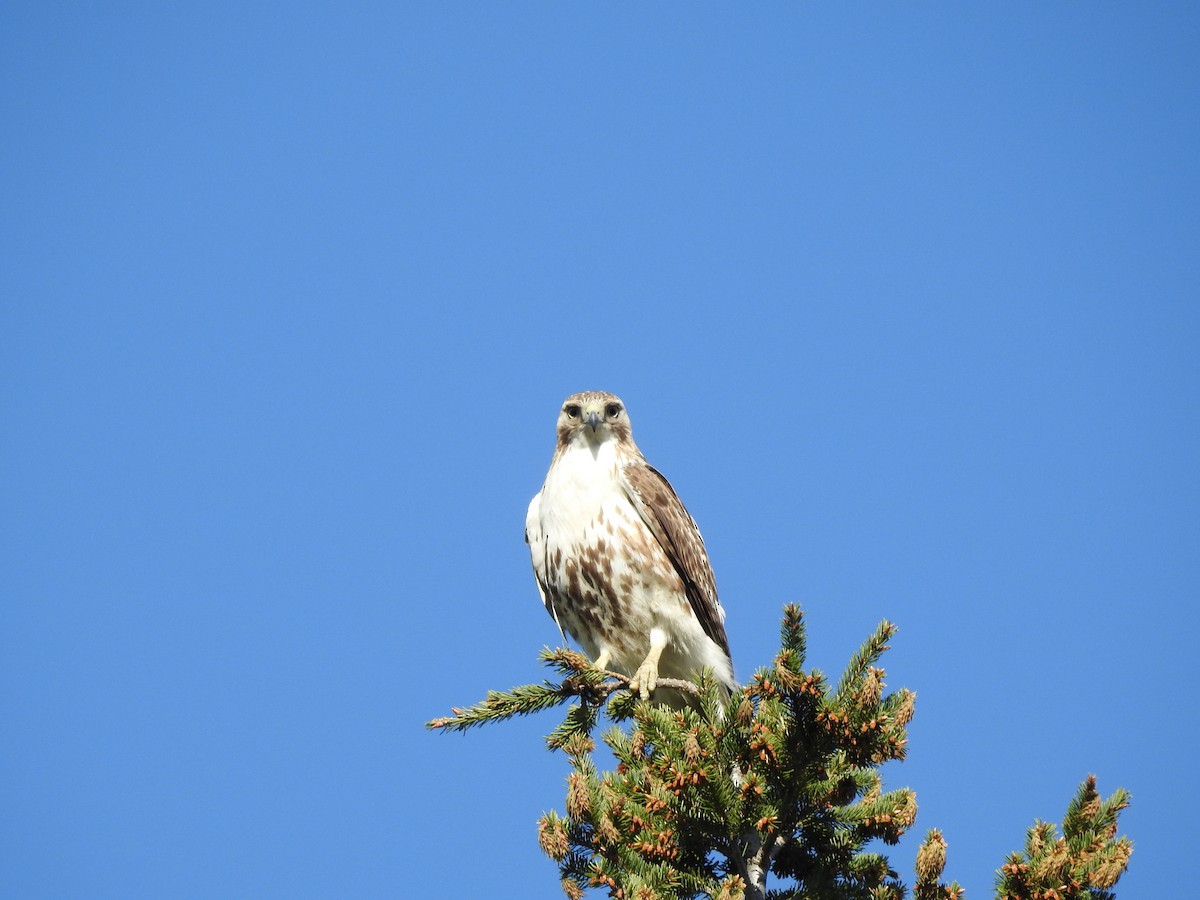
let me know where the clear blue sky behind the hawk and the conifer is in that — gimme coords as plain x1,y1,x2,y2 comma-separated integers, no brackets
0,2,1200,898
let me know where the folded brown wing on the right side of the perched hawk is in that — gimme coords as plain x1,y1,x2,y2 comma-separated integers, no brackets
622,461,730,656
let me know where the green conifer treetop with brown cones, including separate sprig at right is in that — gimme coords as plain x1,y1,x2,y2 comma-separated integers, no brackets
428,605,1133,900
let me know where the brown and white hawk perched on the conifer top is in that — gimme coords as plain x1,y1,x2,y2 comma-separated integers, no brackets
526,391,736,706
